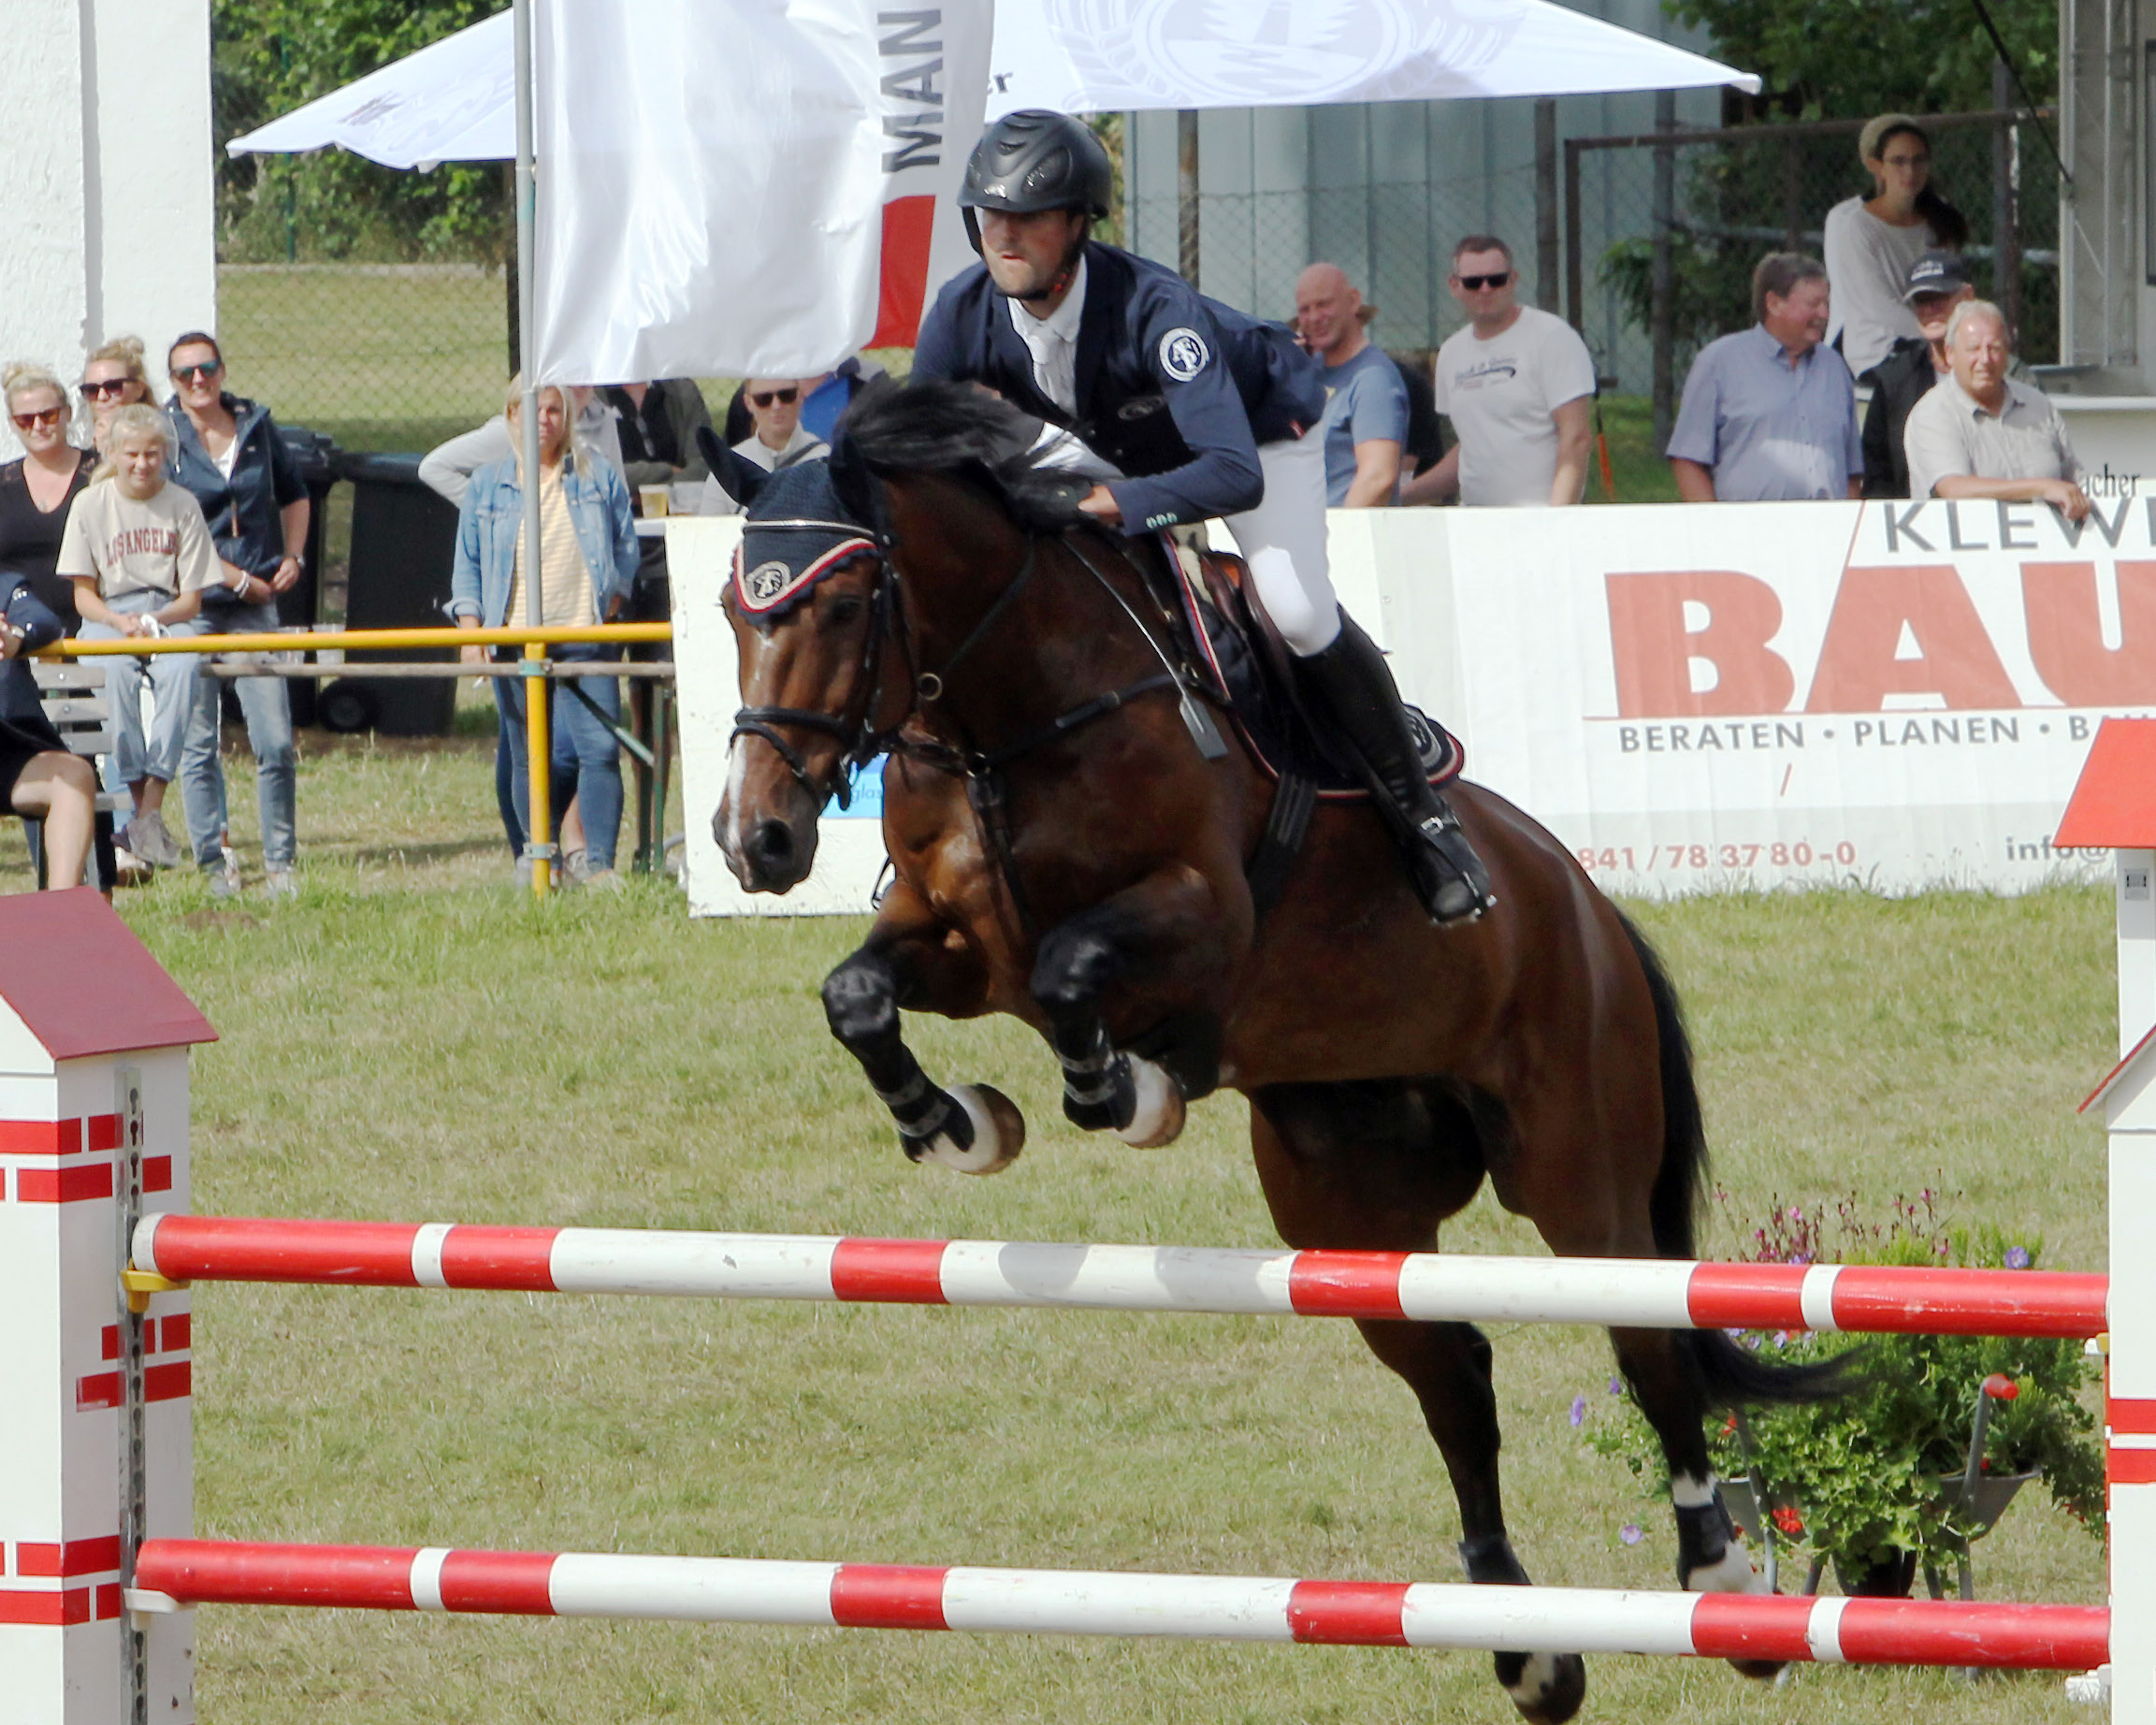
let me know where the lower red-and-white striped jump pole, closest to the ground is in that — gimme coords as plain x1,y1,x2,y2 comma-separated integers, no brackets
136,1540,2111,1671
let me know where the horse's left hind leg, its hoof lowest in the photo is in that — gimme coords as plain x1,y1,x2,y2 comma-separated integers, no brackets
1251,1082,1586,1725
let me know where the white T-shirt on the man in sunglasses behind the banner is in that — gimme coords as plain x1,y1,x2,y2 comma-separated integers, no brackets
1436,306,1596,507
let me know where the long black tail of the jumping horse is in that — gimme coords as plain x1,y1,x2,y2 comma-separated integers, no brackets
1617,912,1857,1408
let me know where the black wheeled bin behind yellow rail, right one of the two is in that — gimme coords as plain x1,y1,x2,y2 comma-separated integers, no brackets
329,455,457,737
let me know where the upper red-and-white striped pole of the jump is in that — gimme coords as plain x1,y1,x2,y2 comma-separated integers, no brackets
134,1216,2108,1337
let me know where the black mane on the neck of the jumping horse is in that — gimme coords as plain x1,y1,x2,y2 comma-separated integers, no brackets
832,380,1091,529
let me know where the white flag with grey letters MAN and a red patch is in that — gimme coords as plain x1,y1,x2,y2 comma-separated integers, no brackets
535,0,990,384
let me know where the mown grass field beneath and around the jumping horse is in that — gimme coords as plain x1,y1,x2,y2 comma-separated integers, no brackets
17,716,2113,1725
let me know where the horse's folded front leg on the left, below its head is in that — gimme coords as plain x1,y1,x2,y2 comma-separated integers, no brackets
824,882,1026,1173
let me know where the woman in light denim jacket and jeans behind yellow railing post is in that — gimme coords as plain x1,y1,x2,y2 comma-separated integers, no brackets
448,377,638,886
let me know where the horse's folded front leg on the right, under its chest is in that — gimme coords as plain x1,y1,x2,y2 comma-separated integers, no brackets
1031,864,1229,1150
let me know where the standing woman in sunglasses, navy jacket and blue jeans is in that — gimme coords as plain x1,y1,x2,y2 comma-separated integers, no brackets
164,330,311,899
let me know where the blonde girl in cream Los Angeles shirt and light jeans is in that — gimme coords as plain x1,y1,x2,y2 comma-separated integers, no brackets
61,403,218,869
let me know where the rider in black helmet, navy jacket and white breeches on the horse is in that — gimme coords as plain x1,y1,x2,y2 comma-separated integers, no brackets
914,110,1492,923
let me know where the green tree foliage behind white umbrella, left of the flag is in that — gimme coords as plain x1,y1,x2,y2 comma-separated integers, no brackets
211,0,509,263
